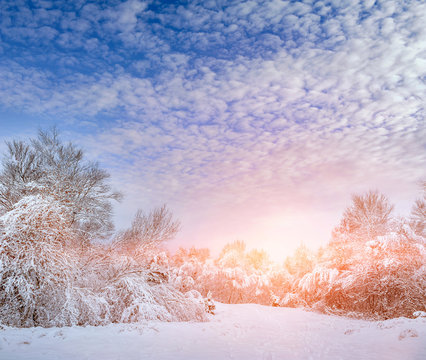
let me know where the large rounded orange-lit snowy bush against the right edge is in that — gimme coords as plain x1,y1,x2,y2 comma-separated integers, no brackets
332,233,426,318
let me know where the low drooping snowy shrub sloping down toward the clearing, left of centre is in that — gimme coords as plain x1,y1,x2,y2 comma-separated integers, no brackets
84,253,205,322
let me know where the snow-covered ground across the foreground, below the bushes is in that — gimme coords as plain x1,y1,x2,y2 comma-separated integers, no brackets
0,304,426,360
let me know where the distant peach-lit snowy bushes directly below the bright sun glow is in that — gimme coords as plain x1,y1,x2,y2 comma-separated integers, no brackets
170,241,285,305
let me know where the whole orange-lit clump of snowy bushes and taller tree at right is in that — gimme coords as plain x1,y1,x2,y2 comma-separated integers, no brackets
279,192,426,319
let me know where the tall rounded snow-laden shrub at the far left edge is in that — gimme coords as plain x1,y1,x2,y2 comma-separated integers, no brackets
0,195,78,326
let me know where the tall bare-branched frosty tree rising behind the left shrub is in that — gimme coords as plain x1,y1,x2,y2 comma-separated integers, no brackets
0,129,121,241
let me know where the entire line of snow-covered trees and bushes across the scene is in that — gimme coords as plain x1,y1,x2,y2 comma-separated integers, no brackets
0,129,426,327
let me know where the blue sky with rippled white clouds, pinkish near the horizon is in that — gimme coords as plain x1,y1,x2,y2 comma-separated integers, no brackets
0,0,426,259
